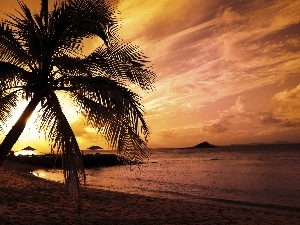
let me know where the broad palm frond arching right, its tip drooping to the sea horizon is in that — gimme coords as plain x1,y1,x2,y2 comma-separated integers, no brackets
69,77,149,161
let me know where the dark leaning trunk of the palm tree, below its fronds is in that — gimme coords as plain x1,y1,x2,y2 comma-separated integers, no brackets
0,95,41,166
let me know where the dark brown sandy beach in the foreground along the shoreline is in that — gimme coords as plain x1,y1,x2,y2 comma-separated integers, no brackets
0,162,300,225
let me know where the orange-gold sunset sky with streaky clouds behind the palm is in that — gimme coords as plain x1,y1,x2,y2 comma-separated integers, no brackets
0,0,300,153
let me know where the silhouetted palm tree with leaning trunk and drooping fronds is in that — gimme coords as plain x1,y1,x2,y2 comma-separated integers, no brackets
0,0,155,213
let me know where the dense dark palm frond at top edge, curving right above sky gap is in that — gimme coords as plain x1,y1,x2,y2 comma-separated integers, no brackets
49,0,116,55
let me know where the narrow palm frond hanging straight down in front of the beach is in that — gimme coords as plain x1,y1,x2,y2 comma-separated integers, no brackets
39,92,85,214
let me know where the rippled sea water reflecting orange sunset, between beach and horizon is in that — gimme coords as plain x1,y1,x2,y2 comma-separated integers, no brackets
34,144,300,210
